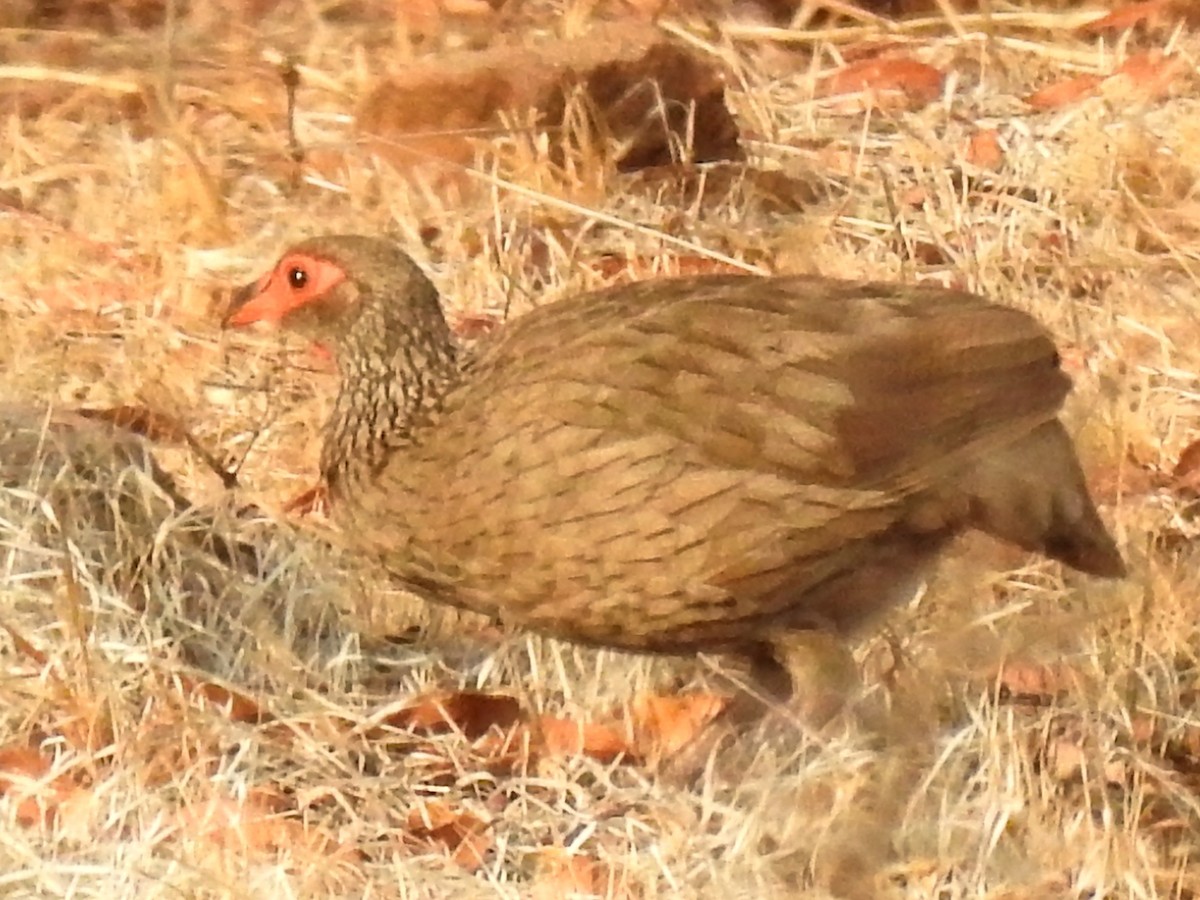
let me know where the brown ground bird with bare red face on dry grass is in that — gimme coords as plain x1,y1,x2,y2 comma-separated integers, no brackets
223,235,1127,698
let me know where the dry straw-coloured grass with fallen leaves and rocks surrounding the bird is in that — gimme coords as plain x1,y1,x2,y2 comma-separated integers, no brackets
0,0,1200,900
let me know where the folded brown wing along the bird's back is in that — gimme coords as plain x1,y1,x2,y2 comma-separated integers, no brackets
458,276,1070,501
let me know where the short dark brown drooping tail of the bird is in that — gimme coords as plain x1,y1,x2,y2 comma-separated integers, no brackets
960,420,1126,578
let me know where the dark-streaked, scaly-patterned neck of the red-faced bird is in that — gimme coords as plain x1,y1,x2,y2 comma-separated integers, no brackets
320,295,461,492
